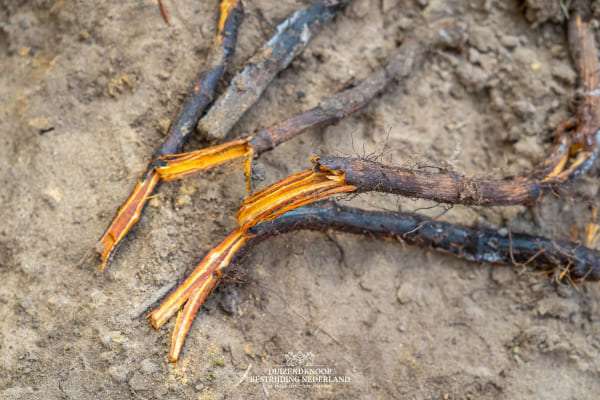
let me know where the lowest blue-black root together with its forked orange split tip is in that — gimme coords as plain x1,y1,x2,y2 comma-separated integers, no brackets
156,192,600,362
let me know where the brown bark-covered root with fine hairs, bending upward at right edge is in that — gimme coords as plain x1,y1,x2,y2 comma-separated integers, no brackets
317,7,600,206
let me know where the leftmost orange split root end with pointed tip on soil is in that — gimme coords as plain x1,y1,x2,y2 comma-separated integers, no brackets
98,171,160,270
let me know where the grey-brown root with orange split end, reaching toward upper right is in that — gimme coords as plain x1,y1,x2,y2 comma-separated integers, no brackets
157,19,465,181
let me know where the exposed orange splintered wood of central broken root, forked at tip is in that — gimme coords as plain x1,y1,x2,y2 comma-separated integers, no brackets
148,162,356,362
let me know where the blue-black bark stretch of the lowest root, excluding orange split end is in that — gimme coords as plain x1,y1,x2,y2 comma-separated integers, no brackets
247,202,600,281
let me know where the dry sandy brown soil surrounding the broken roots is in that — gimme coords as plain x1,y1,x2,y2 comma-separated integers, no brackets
0,0,600,400
